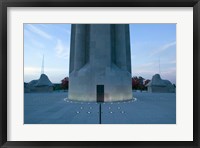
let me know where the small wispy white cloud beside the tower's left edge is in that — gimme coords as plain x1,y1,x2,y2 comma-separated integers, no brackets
55,39,69,59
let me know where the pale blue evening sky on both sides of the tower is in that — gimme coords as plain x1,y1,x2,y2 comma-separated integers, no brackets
24,24,176,84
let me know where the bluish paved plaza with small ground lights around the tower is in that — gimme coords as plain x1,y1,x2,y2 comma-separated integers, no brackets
24,92,176,124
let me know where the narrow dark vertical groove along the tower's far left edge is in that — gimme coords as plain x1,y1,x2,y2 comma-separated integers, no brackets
69,24,76,73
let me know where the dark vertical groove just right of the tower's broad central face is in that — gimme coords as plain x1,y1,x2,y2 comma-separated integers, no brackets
110,24,116,64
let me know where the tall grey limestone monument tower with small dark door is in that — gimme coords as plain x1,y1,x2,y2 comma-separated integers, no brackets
68,24,132,102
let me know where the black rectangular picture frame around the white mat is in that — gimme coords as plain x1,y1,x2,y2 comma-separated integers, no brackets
0,0,200,148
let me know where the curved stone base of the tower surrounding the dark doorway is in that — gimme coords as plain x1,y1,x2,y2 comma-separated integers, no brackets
68,66,132,102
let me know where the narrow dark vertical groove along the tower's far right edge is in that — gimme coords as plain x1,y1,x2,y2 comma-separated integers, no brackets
125,24,131,73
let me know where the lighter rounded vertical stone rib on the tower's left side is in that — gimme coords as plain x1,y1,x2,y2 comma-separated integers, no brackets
74,24,86,70
